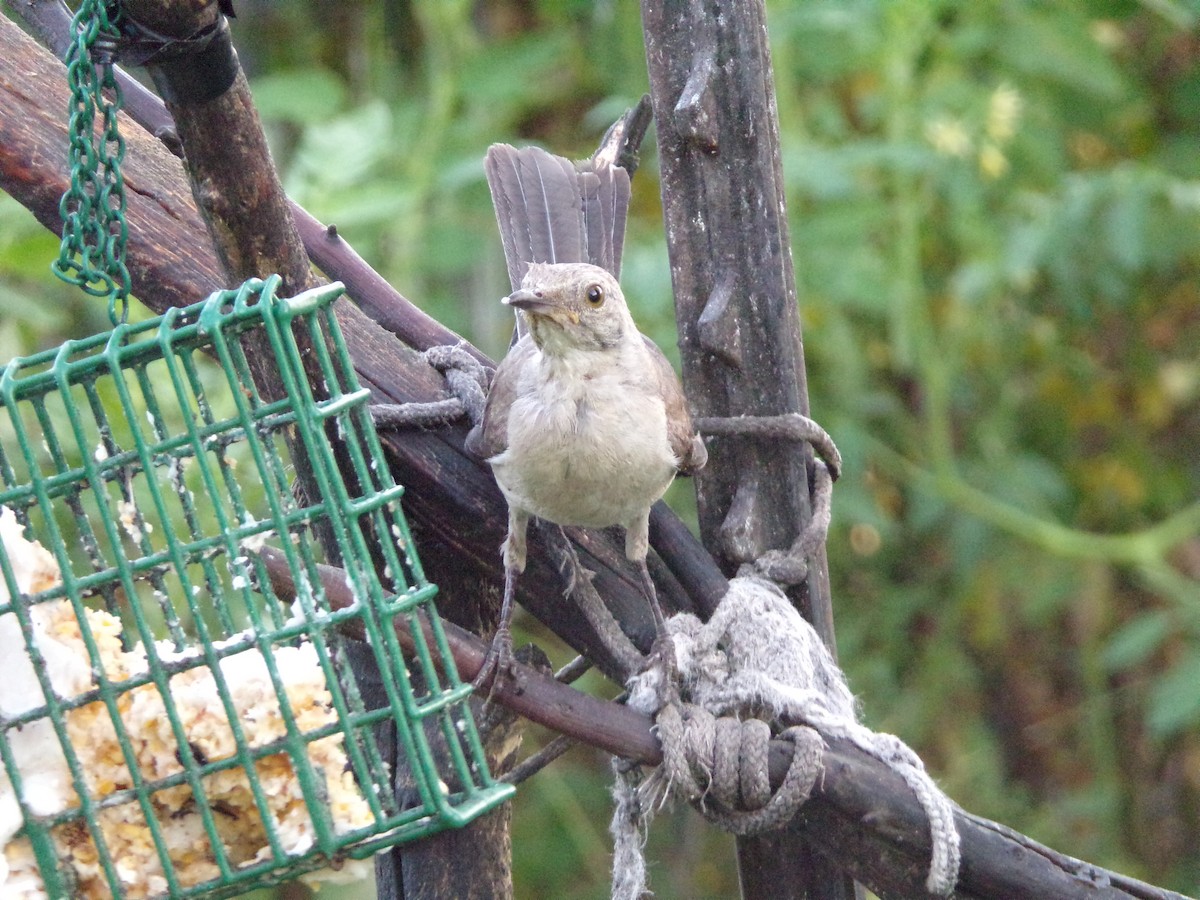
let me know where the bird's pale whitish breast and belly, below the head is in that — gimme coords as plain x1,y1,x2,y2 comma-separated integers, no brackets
490,336,677,528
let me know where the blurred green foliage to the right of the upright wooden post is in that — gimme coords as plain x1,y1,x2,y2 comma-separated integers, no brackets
772,0,1200,890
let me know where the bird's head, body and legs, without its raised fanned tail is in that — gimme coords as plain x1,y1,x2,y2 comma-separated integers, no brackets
467,263,708,685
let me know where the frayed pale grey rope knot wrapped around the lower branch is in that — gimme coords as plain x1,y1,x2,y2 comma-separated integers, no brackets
612,576,960,900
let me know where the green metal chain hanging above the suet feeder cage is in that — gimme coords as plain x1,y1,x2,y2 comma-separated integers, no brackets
50,0,130,325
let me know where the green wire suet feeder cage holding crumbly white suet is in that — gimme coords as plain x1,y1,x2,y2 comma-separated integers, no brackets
0,278,512,898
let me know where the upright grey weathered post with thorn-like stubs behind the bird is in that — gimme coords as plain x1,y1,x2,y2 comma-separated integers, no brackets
642,0,856,900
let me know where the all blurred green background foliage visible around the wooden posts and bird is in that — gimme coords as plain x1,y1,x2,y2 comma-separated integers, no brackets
0,0,1200,898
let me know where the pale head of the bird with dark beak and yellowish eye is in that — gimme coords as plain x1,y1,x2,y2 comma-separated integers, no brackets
504,263,636,353
